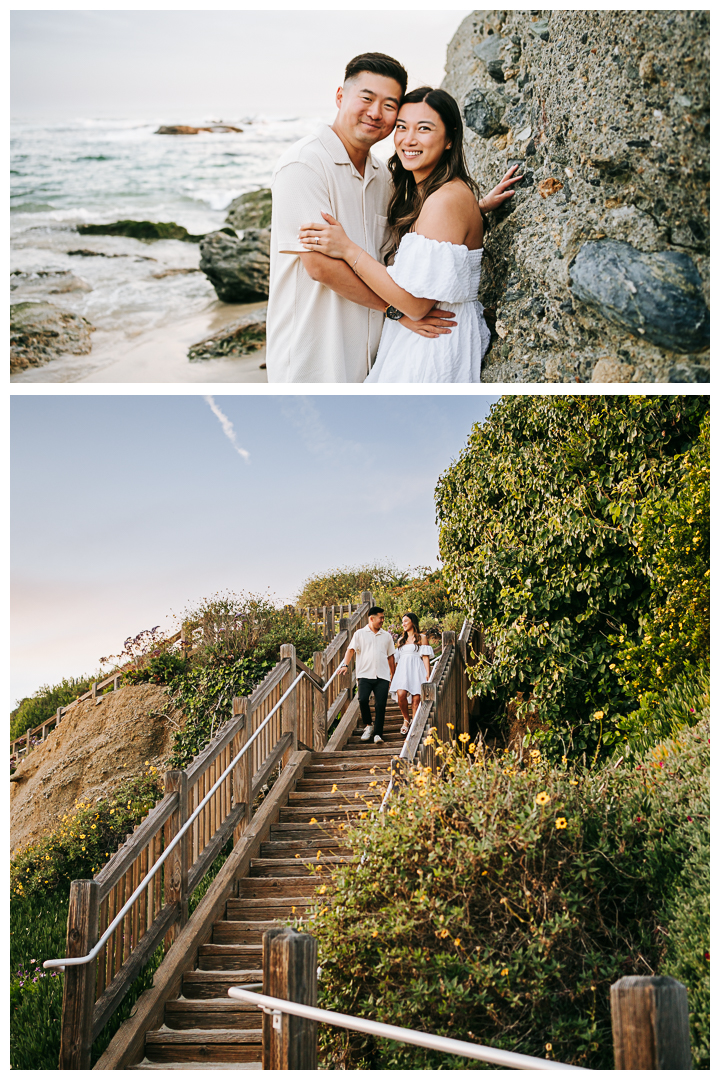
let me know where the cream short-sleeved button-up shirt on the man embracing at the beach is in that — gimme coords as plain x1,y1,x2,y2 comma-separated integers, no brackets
267,124,391,382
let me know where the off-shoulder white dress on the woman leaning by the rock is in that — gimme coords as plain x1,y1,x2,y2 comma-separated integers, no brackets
365,232,490,382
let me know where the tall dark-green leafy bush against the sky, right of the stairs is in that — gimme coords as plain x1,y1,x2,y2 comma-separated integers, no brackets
436,395,708,757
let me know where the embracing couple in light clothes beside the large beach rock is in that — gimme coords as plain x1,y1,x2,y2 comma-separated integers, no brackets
267,53,520,382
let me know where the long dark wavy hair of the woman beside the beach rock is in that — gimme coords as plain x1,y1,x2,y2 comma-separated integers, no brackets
388,86,480,257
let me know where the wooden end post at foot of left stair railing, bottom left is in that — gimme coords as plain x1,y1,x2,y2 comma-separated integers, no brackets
59,881,99,1069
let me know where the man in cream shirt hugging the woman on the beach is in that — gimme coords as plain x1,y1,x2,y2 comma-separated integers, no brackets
267,53,453,382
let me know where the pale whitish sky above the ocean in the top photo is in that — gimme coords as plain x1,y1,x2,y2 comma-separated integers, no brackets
11,10,470,123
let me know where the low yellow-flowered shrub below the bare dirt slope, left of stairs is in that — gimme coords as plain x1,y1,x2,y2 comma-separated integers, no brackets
10,766,163,897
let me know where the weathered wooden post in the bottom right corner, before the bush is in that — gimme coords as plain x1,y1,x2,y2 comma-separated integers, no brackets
610,975,692,1070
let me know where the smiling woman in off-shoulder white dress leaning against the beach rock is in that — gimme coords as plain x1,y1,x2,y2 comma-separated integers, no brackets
299,86,496,382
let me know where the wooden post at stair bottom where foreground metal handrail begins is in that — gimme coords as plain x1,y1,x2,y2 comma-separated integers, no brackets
262,930,317,1069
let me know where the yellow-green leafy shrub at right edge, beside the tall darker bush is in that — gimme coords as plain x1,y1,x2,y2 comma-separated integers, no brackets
617,415,710,700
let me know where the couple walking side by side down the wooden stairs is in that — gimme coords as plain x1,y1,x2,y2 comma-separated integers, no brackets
338,607,433,743
